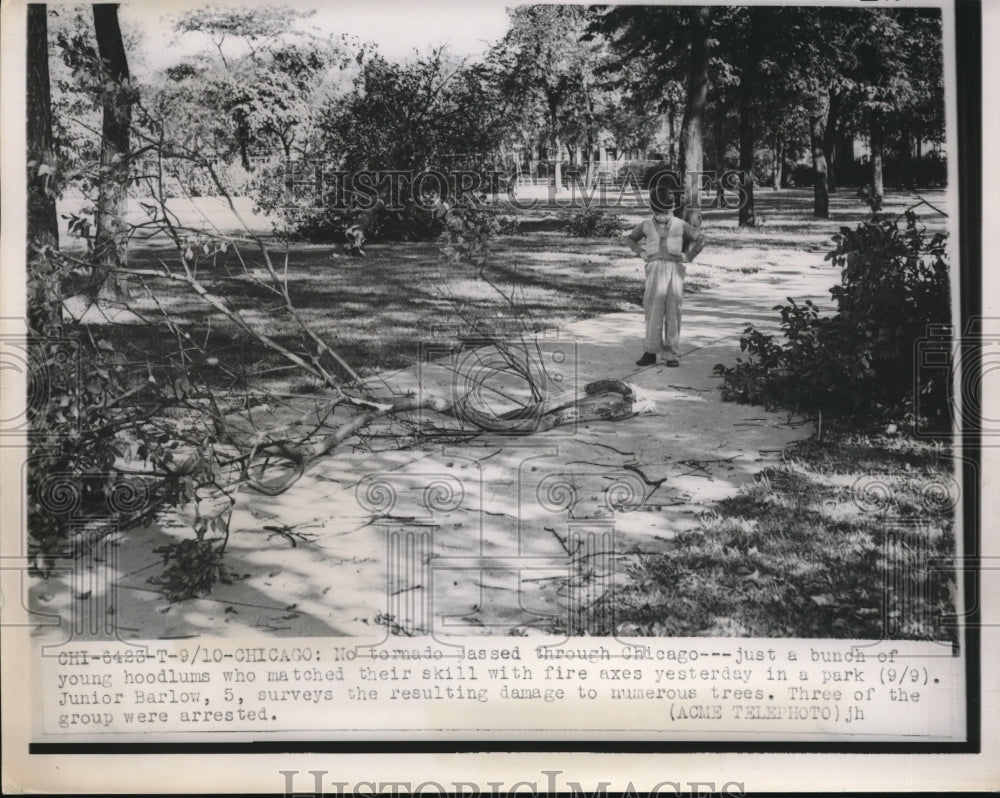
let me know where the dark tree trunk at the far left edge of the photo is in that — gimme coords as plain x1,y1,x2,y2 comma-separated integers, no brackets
27,3,59,259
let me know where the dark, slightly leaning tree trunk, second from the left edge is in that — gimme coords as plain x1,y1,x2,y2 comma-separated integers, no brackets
89,3,132,298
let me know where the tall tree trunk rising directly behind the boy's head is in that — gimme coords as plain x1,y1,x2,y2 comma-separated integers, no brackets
678,6,712,227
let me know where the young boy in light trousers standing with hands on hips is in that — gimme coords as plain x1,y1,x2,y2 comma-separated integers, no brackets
622,190,705,366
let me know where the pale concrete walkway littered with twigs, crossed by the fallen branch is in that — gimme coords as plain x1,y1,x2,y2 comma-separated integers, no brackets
32,244,836,639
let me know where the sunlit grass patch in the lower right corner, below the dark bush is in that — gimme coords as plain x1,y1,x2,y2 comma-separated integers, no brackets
611,424,956,641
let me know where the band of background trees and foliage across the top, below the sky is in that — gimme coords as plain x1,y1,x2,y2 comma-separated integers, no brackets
29,5,944,263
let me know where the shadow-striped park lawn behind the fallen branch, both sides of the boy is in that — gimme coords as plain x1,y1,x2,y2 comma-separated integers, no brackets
106,190,932,392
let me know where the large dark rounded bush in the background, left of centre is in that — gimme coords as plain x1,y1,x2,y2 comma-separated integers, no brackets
252,48,509,242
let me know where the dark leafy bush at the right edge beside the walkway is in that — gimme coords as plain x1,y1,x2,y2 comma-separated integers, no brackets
715,209,951,421
